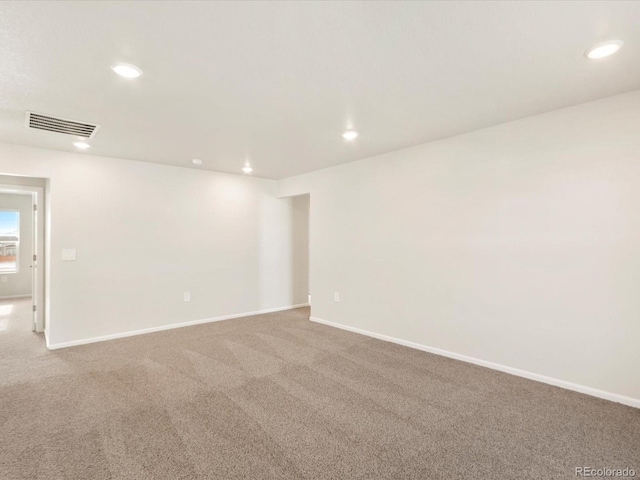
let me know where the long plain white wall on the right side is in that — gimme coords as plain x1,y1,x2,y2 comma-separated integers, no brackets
279,91,640,399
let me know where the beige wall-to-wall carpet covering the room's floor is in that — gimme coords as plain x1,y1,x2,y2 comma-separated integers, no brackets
0,302,640,480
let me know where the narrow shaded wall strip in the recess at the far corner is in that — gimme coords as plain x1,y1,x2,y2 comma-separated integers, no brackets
291,195,309,304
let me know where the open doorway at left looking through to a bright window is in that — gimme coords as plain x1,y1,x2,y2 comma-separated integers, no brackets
0,184,45,332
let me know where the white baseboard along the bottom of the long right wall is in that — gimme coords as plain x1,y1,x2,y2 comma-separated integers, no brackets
309,317,640,408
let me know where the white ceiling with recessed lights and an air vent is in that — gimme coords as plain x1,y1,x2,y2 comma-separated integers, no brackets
0,1,640,178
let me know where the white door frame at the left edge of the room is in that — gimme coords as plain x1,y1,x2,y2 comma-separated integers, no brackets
0,184,48,332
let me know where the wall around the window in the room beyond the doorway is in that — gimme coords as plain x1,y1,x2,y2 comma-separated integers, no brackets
0,193,33,298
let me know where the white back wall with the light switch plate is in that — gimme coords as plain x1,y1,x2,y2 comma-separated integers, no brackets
0,144,294,345
